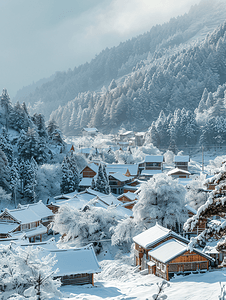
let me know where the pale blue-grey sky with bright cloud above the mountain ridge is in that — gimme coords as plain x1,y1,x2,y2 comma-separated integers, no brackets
0,0,200,98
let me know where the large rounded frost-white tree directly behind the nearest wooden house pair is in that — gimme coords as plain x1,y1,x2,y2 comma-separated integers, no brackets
133,174,187,231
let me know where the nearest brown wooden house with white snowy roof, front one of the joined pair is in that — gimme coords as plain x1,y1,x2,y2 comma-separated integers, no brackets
147,239,213,280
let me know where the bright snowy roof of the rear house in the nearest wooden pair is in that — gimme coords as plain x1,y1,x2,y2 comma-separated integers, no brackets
133,224,189,249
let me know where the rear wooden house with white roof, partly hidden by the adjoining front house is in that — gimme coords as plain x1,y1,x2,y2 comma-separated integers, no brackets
133,223,189,270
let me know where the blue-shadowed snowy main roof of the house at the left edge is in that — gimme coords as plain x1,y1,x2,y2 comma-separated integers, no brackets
0,206,41,224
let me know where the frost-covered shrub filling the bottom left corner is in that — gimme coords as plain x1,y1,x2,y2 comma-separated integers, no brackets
0,245,60,300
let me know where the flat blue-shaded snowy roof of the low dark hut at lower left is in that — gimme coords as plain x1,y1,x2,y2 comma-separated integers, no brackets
46,245,101,276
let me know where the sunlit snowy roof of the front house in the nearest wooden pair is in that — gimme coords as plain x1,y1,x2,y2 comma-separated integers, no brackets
148,239,213,263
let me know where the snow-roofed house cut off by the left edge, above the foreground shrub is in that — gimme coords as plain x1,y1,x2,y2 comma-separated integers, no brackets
0,205,47,242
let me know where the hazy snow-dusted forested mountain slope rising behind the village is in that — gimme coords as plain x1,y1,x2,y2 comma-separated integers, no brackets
15,0,226,134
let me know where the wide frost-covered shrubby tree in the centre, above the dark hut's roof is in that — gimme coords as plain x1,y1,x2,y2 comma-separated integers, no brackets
53,205,118,253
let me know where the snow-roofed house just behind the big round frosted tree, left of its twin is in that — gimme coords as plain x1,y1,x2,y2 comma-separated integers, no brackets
138,155,164,174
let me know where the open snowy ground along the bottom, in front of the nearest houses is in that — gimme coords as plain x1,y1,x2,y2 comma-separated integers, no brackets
61,260,226,300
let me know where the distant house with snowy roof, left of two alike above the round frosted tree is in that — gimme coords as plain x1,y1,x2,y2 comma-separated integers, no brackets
138,155,164,177
